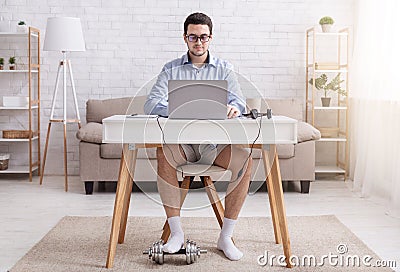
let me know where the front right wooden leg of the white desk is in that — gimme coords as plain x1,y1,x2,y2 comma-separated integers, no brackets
270,145,292,268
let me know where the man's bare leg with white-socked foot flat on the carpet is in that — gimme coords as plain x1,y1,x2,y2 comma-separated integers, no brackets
214,145,252,261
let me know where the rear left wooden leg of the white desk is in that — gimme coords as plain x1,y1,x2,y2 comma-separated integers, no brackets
118,146,138,244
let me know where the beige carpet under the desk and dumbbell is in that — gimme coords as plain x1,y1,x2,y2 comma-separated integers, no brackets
11,216,392,272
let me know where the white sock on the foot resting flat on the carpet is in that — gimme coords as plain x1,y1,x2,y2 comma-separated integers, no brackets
217,217,243,261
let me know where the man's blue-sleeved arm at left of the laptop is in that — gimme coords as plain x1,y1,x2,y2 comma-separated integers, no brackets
144,66,168,116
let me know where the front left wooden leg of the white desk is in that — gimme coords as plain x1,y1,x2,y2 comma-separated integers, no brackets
106,144,132,268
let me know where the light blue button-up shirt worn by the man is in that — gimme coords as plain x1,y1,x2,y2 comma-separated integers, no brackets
144,52,245,116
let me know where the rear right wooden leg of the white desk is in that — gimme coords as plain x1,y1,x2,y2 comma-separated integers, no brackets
262,149,282,244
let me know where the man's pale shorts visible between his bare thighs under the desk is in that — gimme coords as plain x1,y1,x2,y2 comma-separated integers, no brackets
181,144,227,165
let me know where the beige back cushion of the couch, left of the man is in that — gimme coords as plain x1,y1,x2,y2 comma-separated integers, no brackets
86,96,146,123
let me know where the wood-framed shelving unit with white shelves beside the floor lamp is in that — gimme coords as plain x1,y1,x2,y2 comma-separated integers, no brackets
0,27,40,181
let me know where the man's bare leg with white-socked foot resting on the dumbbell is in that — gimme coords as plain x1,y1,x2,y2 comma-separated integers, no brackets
157,145,186,253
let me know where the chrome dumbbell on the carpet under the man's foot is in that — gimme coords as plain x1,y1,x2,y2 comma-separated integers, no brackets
143,240,207,264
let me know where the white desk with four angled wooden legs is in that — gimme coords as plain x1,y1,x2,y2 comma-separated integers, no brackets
103,115,297,268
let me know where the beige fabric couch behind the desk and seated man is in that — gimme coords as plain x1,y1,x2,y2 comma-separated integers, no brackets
77,96,320,194
